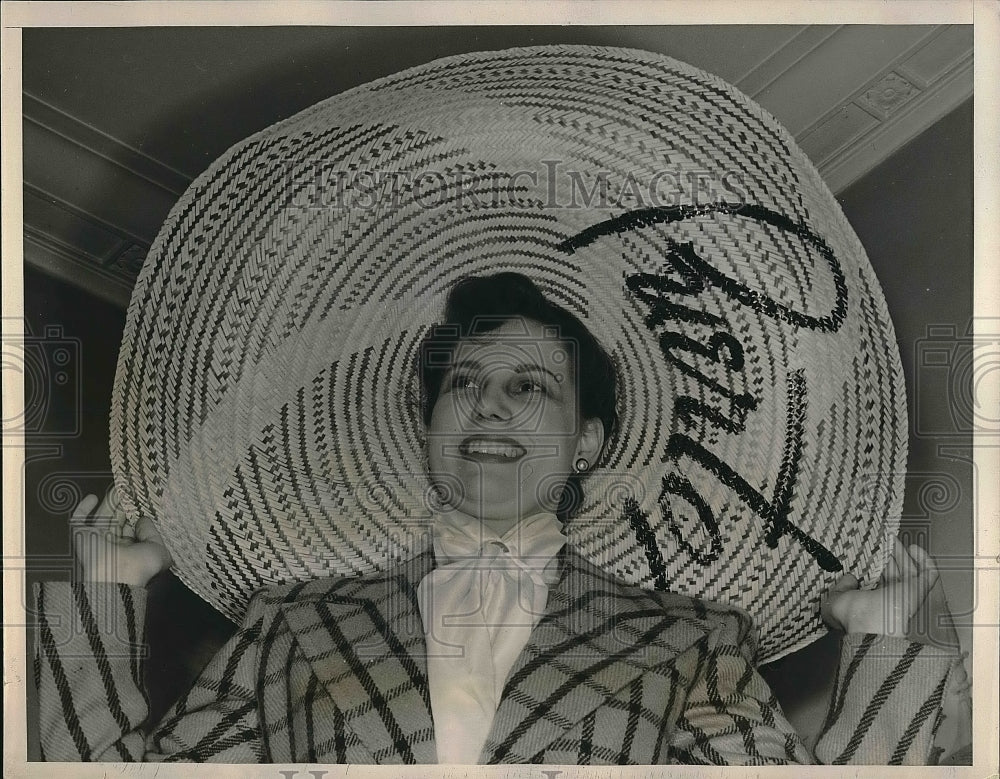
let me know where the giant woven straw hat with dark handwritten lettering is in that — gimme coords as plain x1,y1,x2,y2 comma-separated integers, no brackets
112,46,905,657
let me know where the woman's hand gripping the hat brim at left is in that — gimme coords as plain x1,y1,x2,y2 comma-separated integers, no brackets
70,491,173,587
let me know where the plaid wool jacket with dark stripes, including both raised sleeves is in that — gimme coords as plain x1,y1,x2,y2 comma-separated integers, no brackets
35,551,954,765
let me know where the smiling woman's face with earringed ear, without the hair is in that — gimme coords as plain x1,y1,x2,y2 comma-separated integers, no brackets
427,318,604,530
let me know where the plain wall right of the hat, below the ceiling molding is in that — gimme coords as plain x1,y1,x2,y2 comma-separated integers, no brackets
839,100,968,649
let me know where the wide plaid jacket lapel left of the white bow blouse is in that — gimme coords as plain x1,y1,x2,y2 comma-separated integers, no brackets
282,552,437,763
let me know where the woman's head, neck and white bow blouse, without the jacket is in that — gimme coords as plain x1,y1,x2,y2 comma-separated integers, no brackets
417,273,615,763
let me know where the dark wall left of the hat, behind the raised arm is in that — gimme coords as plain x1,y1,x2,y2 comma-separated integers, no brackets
23,268,232,759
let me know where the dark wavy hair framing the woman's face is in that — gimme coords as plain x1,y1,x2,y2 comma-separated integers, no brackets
419,272,618,519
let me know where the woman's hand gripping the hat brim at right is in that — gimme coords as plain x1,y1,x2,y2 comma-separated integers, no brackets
820,538,947,638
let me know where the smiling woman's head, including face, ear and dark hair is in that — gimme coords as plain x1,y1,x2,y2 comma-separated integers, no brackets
420,273,618,526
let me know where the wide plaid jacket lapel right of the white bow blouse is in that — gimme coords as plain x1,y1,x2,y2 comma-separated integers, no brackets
480,552,701,763
